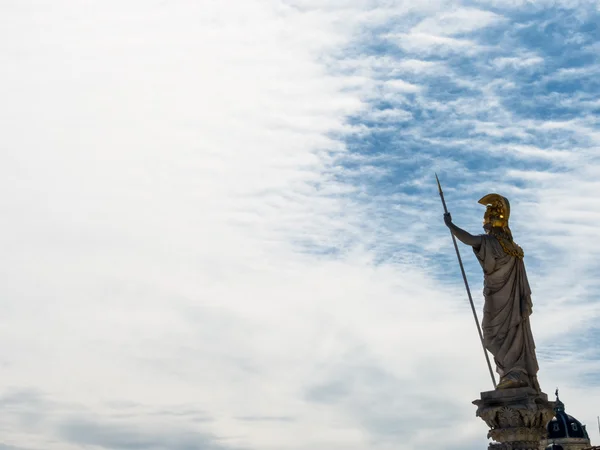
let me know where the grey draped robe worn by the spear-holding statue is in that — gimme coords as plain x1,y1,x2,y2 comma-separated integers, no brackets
473,235,540,391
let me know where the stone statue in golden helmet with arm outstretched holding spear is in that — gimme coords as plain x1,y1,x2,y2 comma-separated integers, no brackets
440,193,541,392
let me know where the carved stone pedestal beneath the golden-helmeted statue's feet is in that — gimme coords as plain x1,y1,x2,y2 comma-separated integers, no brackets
473,388,554,450
